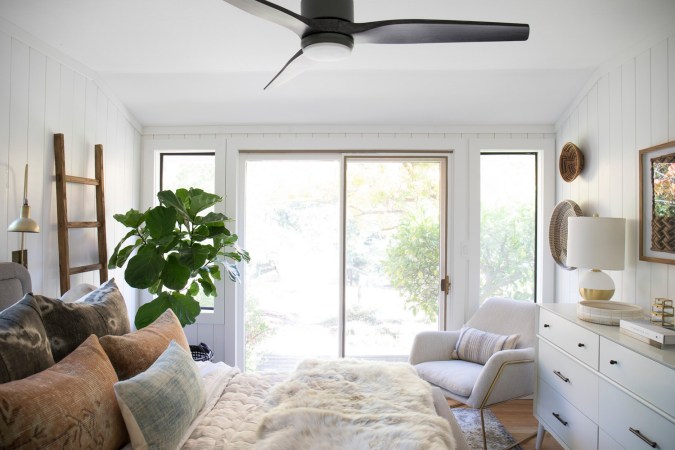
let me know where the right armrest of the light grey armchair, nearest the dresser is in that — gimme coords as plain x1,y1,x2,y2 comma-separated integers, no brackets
467,347,534,408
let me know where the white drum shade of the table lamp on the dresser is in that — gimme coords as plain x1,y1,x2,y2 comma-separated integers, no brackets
567,217,626,270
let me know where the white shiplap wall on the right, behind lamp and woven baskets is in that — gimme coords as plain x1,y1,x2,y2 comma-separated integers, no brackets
556,36,675,308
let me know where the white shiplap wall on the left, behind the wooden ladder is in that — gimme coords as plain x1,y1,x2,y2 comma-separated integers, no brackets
0,21,141,317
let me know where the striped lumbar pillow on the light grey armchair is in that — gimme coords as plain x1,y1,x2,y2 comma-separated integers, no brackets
452,327,519,364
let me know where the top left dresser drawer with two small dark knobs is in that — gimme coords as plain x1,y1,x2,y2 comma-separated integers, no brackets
539,308,600,370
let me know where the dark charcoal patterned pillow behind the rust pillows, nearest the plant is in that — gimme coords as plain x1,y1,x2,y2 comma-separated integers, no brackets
35,279,130,362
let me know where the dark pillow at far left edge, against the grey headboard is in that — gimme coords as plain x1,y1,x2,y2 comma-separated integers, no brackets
0,294,54,383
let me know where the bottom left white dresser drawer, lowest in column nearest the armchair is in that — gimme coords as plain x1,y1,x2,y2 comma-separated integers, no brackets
536,378,598,450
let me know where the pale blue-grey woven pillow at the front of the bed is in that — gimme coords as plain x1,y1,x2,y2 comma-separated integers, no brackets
114,341,206,450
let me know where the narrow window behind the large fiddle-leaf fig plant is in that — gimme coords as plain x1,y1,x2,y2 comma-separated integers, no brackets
159,151,216,310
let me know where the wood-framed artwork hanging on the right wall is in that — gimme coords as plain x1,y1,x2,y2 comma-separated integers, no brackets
639,141,675,264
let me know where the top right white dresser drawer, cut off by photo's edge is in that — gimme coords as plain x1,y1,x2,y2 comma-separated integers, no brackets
600,337,675,417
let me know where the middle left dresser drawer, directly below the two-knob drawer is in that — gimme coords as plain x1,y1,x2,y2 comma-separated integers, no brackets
537,339,598,422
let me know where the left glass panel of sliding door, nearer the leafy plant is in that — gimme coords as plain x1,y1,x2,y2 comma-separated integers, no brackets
244,160,340,371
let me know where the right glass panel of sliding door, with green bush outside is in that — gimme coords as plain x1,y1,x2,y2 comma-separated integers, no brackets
344,157,445,361
